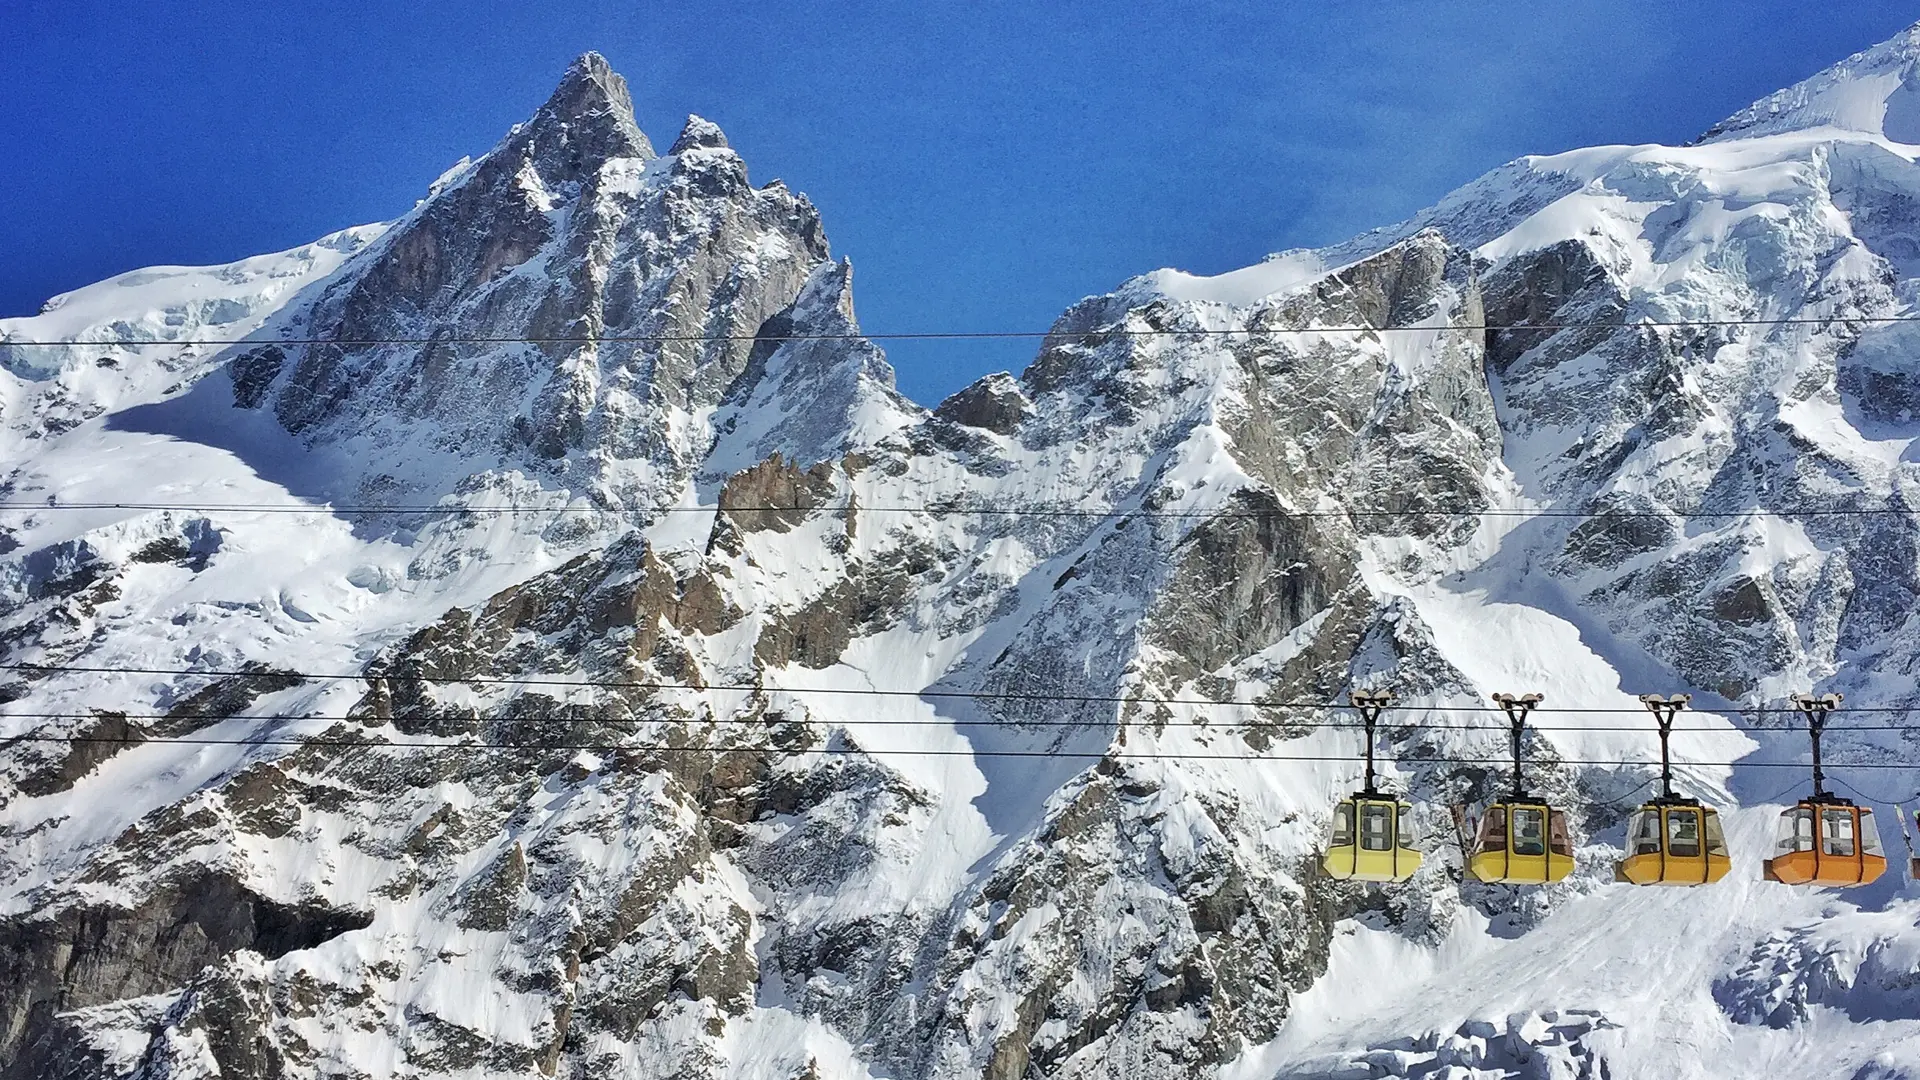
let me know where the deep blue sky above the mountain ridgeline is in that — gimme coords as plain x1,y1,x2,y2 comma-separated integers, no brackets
0,0,1920,402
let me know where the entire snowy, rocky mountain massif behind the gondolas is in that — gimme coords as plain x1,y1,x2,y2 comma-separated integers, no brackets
0,27,1920,1080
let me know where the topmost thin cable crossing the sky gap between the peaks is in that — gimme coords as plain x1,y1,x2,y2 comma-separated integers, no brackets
0,315,1920,348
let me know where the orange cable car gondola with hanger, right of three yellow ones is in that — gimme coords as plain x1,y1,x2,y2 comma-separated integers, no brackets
1764,694,1887,888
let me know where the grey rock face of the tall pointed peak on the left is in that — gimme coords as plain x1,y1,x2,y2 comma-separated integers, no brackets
232,54,848,503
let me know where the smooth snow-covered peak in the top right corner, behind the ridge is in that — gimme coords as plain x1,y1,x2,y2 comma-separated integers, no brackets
1695,23,1920,142
